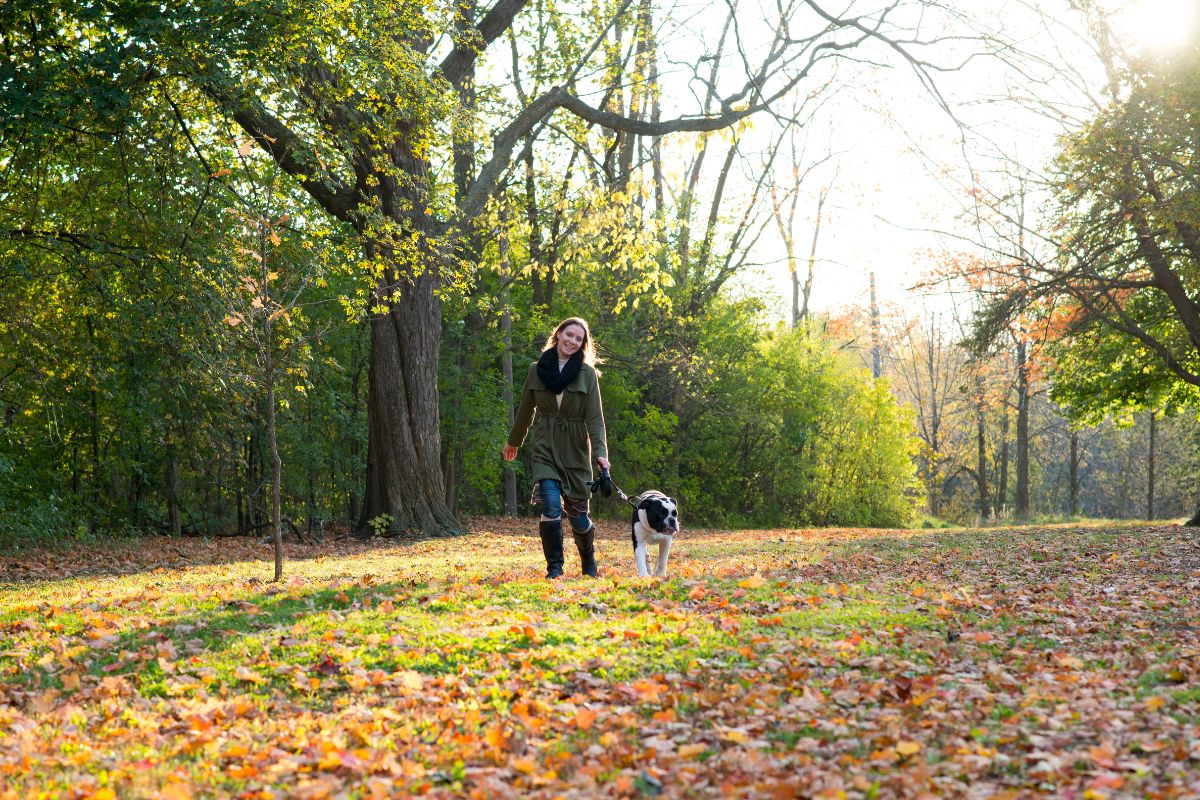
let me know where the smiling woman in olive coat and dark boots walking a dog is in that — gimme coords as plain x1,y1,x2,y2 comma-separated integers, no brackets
504,317,610,579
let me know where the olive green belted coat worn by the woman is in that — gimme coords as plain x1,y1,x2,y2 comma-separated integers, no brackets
509,361,608,500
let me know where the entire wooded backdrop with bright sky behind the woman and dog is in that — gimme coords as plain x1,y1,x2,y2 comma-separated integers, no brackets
0,0,1200,547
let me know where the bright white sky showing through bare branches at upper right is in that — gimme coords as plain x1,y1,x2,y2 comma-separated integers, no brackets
490,0,1200,319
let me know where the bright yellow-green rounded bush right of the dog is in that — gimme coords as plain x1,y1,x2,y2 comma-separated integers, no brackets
667,320,916,525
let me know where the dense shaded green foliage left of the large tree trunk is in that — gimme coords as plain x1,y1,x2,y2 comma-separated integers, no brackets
0,43,365,545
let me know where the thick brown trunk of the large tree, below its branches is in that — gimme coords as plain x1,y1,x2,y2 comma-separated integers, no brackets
358,263,460,537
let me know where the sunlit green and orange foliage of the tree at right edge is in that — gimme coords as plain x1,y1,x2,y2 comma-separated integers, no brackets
1046,47,1200,423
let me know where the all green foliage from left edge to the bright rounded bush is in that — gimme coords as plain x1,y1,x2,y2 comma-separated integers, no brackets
0,0,913,542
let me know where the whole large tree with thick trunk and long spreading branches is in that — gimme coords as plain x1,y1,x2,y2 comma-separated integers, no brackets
0,0,998,533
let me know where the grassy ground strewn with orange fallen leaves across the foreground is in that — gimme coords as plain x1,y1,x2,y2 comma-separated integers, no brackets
0,519,1200,799
